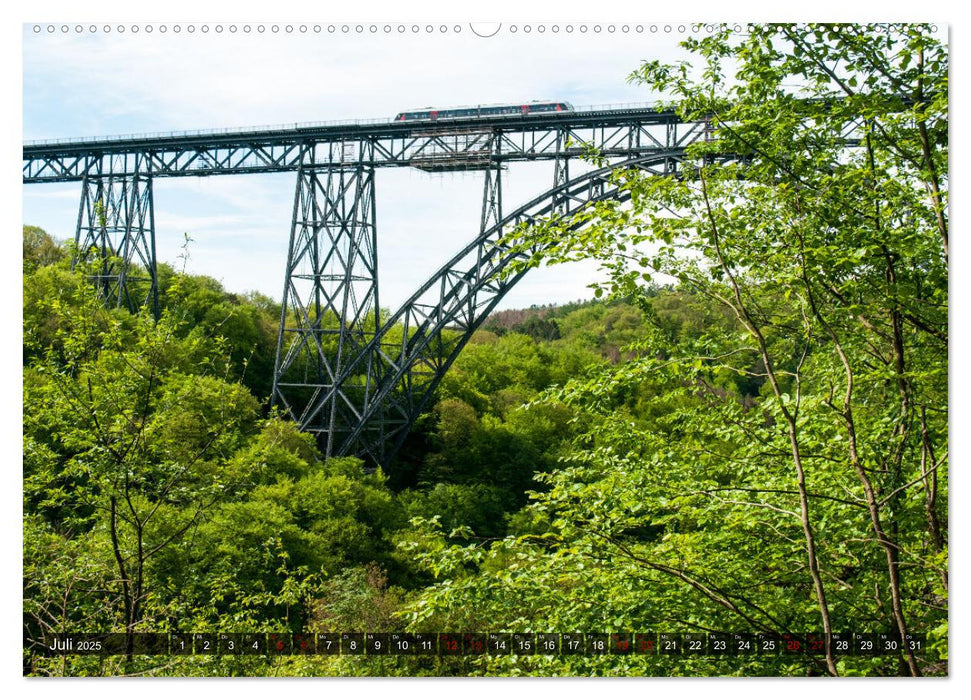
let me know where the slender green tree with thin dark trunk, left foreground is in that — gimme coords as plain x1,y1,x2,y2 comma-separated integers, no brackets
24,272,258,659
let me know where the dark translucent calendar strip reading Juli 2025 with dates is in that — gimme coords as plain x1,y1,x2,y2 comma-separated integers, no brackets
24,632,926,657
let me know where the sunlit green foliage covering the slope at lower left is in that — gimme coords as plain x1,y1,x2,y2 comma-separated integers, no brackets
24,256,406,675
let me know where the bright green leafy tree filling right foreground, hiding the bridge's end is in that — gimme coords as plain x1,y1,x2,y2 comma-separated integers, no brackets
402,25,948,675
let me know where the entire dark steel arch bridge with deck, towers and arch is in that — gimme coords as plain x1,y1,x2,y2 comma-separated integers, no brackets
23,106,710,467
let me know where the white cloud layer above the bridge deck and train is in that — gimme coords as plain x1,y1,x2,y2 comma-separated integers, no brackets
24,25,675,138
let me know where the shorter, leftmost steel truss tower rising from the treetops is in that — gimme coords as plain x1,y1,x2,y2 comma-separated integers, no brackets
73,154,158,318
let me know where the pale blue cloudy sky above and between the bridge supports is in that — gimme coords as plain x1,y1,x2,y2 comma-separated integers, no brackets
23,22,691,308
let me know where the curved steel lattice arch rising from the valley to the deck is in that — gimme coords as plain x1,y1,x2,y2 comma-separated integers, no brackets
296,149,684,466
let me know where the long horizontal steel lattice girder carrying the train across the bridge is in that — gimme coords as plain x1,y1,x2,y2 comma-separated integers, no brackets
23,109,705,183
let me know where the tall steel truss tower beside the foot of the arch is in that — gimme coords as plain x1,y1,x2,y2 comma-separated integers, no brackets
273,142,384,459
